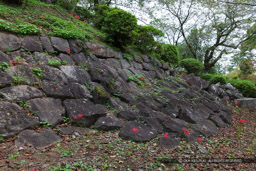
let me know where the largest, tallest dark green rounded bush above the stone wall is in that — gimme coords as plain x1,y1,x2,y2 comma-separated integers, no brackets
95,5,137,49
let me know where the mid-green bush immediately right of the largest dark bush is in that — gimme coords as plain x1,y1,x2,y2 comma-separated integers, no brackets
133,25,164,53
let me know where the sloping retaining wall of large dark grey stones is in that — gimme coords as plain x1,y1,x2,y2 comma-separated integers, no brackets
0,33,242,148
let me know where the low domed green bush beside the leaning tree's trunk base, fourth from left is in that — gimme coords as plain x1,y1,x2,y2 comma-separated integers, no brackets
180,58,204,75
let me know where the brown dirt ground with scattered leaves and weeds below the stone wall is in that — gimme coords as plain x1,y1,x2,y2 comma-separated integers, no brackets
0,107,256,171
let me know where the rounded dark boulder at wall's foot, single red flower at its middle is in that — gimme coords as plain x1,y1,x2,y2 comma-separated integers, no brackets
119,121,157,142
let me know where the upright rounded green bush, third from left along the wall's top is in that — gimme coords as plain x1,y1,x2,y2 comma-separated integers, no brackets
156,44,179,66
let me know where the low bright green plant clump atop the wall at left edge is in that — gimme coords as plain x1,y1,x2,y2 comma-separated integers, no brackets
0,19,41,35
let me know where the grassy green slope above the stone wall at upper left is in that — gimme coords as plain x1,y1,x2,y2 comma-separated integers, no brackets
0,0,105,42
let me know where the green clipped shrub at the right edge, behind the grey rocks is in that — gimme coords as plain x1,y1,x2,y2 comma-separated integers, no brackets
228,79,256,98
